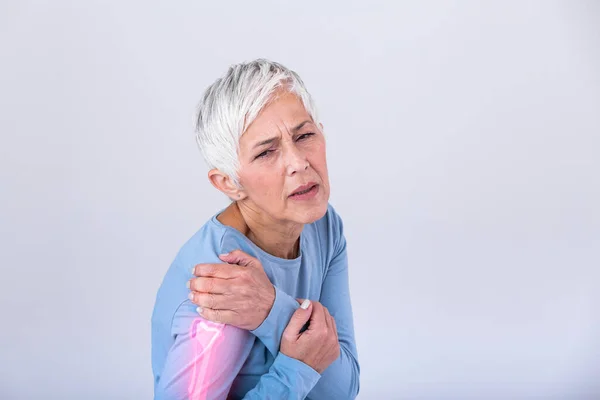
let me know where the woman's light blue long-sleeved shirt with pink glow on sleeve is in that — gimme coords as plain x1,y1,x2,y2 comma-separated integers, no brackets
152,205,360,400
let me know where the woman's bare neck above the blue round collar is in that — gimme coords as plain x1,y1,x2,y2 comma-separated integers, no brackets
217,202,304,259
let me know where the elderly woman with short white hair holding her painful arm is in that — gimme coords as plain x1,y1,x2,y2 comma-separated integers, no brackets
152,60,360,400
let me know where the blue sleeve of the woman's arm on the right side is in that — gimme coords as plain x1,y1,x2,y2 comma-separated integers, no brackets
307,214,360,400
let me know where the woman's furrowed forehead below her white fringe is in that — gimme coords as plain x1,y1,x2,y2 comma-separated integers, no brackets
240,92,311,143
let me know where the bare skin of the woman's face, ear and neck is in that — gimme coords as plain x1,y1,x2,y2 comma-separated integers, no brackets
209,92,329,258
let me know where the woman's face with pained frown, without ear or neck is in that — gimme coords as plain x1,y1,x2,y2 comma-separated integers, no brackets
239,92,329,224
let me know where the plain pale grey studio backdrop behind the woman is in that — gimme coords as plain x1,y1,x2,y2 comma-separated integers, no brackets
0,1,600,400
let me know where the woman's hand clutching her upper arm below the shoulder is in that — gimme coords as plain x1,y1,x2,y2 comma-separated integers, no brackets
188,250,275,330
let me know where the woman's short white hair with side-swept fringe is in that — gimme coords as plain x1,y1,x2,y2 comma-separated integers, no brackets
196,59,318,187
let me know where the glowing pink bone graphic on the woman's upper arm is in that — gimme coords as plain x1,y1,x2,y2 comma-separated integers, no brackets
188,319,225,400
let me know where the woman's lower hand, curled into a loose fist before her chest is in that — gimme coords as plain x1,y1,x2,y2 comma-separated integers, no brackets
279,299,340,374
